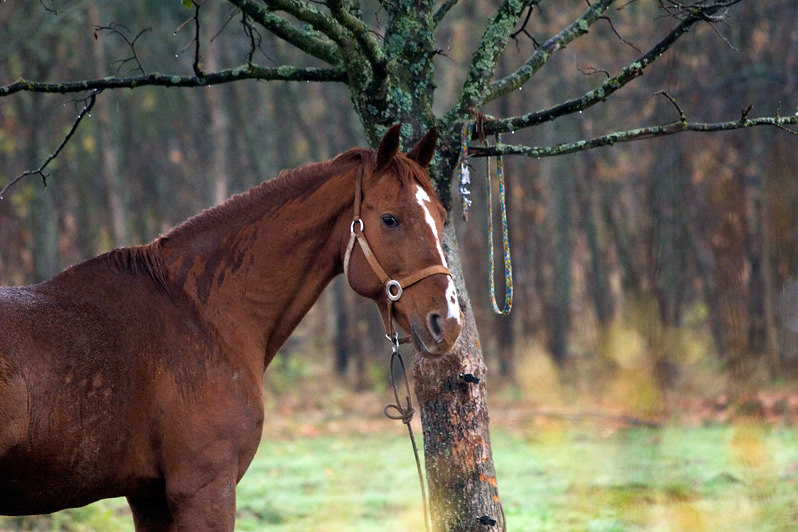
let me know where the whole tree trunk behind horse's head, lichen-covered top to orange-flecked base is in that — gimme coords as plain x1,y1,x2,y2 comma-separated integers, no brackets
348,0,503,520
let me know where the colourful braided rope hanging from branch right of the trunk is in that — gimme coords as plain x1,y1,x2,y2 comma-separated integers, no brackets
457,118,513,316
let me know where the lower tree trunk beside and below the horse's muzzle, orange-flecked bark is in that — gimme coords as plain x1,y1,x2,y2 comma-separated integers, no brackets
413,224,504,532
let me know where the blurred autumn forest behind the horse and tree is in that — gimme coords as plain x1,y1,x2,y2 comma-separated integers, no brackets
0,0,798,528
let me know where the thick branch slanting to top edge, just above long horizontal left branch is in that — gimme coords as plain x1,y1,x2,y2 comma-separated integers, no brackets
228,0,341,65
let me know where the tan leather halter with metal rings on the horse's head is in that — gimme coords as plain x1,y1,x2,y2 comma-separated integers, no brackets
344,165,452,347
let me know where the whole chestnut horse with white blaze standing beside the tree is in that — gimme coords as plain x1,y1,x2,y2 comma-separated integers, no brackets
0,126,461,531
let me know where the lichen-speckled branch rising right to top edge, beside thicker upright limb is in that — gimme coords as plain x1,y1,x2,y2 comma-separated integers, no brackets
484,0,615,103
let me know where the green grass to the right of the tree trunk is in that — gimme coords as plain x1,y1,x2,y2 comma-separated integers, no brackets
496,426,798,531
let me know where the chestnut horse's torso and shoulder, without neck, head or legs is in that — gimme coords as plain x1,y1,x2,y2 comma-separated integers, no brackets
0,222,284,514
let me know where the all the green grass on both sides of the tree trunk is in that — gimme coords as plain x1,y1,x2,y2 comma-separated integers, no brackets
0,418,798,532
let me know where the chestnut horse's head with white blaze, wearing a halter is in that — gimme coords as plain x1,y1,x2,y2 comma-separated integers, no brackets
344,125,462,357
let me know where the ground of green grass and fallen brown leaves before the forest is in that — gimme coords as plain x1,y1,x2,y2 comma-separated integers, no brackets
0,354,798,532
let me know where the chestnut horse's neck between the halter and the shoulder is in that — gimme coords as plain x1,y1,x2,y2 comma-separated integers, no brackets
157,158,357,372
